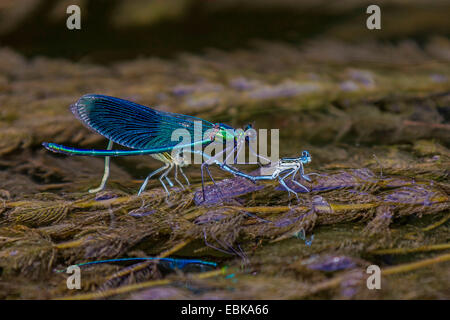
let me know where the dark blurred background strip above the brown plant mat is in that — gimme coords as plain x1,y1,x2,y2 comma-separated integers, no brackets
0,0,450,63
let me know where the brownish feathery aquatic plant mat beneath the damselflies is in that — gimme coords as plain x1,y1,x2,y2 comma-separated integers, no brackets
0,38,450,299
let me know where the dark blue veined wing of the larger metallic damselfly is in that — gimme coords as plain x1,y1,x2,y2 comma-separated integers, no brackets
70,94,214,149
